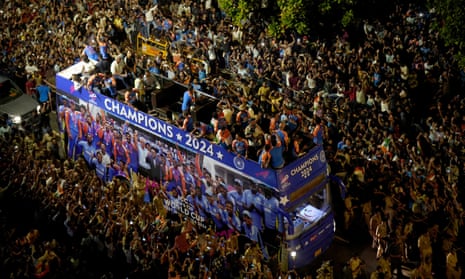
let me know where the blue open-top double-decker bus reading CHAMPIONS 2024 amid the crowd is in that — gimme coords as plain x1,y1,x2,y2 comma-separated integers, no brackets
56,63,342,270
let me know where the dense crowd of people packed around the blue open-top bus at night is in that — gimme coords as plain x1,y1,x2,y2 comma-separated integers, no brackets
0,1,465,278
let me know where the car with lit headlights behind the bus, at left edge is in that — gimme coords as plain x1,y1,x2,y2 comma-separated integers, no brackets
0,75,40,127
